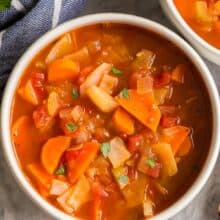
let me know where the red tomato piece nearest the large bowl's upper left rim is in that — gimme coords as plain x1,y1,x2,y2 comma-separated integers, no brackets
31,71,47,99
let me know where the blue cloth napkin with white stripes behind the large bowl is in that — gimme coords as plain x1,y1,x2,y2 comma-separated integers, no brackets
0,0,86,97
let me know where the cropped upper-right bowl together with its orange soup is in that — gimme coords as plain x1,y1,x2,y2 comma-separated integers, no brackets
160,0,220,65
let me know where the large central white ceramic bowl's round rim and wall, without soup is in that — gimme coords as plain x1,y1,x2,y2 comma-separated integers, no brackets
0,13,220,220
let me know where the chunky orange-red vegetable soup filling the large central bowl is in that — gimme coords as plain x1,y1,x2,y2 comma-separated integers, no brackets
11,23,212,220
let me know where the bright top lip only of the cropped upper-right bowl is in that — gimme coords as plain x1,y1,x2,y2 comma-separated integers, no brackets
160,0,220,58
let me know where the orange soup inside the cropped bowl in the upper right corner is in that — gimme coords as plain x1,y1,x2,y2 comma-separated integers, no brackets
174,0,220,49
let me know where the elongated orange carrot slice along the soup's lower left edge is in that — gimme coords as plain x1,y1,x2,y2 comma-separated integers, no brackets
27,163,53,190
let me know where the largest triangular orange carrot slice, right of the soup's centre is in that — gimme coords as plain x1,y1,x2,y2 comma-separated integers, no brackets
115,90,161,131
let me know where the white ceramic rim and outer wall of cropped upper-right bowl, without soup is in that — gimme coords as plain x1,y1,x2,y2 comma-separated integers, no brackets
160,0,220,65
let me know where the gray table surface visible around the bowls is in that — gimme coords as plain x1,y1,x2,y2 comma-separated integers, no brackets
0,0,220,220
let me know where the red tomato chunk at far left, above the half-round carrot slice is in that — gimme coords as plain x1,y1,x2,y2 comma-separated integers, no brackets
33,105,52,128
